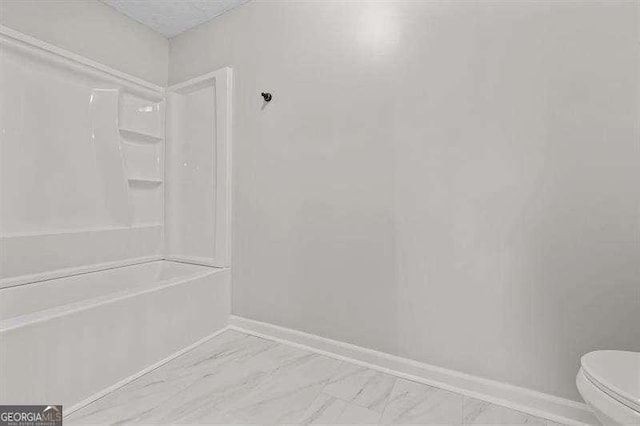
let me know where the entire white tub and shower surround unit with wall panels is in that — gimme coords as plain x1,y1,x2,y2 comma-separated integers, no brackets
0,27,231,412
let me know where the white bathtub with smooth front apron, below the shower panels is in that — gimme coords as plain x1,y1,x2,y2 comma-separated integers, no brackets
0,260,230,408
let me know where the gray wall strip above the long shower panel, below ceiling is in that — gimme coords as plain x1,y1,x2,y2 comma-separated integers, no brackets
0,0,169,85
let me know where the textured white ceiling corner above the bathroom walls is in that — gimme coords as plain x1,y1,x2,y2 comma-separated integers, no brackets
102,0,248,37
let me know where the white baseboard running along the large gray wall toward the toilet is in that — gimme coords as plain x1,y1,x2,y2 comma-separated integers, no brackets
229,316,598,426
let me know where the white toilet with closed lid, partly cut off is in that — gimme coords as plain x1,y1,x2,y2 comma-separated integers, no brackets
576,351,640,425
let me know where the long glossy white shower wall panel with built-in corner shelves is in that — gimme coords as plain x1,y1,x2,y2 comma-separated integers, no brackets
0,30,164,286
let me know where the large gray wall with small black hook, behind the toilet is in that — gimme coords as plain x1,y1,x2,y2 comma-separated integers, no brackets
170,1,640,399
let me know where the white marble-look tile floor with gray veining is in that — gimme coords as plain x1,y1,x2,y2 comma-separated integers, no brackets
65,331,568,426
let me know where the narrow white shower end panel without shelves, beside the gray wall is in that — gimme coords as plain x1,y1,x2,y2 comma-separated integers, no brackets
165,68,231,267
